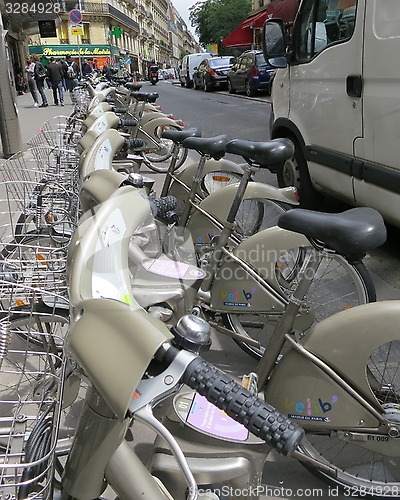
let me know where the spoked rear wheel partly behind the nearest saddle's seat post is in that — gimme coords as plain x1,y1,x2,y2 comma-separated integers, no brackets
223,247,376,360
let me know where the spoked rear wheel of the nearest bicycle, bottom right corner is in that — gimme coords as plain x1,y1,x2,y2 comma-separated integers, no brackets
300,340,400,498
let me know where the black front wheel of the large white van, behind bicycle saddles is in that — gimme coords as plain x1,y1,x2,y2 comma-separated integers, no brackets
277,137,323,209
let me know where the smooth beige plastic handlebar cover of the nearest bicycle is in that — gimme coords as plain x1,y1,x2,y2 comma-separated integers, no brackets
68,299,172,421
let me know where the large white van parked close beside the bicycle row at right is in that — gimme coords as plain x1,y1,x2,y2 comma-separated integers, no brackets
264,0,400,227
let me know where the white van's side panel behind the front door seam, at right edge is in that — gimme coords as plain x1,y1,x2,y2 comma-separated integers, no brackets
354,0,400,226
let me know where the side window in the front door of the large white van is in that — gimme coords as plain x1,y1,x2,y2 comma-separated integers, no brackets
294,0,358,63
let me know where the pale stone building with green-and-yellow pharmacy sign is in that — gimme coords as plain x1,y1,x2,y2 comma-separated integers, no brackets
25,0,196,75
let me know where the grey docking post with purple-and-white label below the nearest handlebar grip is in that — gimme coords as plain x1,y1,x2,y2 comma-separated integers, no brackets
150,387,271,500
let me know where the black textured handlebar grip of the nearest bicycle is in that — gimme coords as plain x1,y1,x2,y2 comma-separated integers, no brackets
182,358,304,456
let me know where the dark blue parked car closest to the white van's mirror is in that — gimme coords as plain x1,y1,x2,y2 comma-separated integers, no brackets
227,50,274,97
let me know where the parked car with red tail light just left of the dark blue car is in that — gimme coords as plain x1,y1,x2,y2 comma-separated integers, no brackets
193,56,234,92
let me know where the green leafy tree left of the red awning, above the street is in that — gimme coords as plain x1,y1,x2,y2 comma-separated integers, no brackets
189,0,251,53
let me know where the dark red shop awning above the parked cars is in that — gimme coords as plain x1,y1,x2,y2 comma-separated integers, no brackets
222,0,299,47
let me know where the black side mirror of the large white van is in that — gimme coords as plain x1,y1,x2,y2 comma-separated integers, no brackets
262,19,287,68
